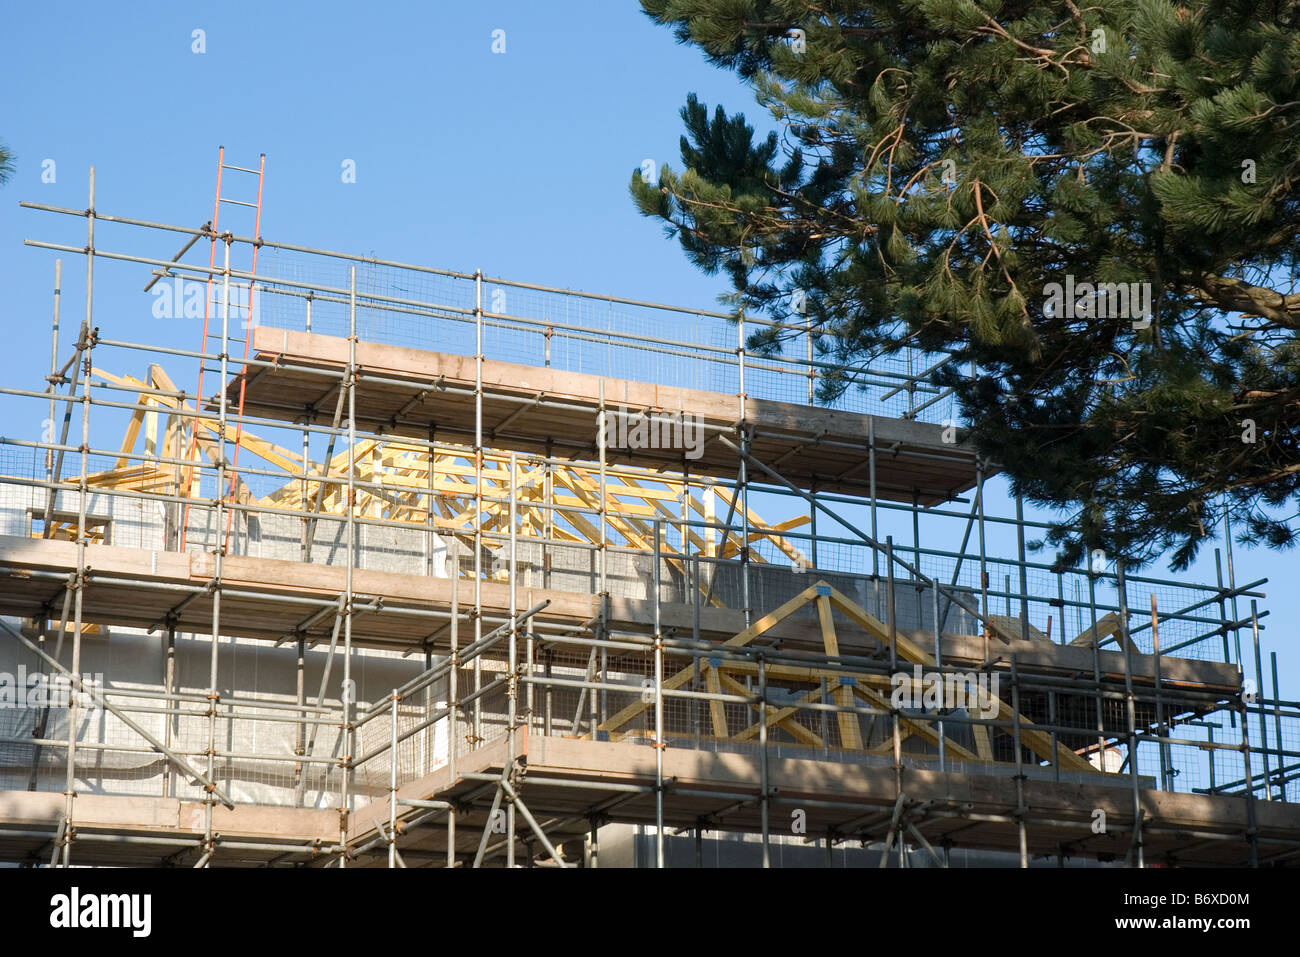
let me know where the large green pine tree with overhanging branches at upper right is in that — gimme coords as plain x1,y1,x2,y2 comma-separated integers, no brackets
631,0,1300,568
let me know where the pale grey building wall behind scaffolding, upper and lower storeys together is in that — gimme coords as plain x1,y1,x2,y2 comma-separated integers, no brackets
0,481,971,806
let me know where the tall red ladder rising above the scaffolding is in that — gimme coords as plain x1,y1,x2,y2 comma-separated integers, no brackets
181,146,267,551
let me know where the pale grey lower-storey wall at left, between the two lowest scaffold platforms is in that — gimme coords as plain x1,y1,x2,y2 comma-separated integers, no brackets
0,629,446,807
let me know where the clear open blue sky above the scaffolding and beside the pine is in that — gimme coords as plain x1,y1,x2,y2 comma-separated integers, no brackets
0,0,1300,698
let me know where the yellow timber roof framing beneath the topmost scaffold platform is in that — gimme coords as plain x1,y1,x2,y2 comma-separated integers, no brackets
81,364,809,606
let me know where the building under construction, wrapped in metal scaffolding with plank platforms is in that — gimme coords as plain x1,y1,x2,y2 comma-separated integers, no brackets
0,153,1300,867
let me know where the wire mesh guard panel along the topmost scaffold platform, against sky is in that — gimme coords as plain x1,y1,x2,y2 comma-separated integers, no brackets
254,247,953,421
